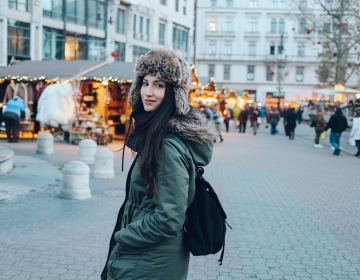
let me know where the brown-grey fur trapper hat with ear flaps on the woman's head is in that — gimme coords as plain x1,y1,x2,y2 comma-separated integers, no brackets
128,49,191,115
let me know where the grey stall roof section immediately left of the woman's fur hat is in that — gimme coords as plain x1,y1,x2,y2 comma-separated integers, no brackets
85,61,135,80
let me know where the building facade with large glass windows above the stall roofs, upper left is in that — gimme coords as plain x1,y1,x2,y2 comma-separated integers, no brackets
0,0,194,66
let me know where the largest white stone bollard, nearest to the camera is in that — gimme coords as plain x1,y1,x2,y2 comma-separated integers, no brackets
60,160,91,199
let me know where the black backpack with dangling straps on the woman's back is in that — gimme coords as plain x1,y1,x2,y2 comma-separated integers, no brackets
184,149,231,265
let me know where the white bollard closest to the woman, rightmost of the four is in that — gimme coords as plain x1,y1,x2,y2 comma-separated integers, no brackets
91,148,115,178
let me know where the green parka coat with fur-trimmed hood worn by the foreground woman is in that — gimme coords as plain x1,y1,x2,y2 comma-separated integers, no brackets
102,109,216,280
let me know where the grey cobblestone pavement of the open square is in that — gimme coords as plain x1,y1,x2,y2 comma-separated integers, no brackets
0,125,360,280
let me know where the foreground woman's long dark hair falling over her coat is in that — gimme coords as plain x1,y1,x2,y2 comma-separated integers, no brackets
130,83,176,197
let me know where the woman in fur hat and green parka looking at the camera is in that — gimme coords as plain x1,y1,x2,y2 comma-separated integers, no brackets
101,50,217,280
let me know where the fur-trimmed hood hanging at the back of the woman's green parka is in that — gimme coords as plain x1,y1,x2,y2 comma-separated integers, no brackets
168,107,218,166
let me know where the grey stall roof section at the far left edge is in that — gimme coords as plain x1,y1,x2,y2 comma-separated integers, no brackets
0,60,104,79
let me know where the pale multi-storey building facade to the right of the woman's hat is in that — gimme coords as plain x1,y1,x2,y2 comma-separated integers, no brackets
195,0,357,105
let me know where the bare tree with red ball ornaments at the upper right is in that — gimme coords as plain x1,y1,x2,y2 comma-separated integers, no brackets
290,0,360,85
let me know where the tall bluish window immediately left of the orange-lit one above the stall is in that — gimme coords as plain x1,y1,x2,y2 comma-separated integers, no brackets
42,26,64,60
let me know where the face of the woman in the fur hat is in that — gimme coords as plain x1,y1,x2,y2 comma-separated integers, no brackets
141,74,166,112
